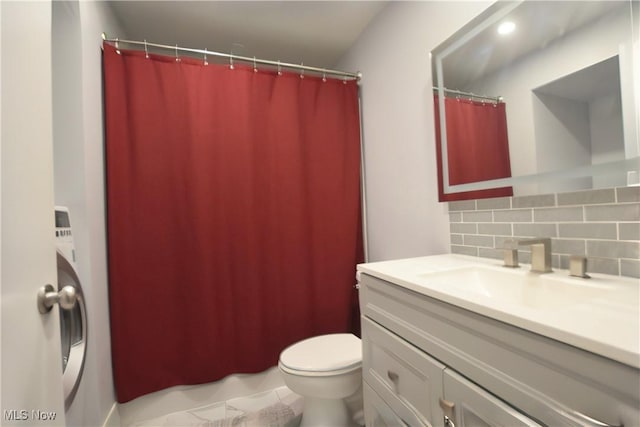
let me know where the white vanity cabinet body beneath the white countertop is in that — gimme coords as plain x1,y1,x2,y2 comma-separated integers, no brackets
360,271,640,427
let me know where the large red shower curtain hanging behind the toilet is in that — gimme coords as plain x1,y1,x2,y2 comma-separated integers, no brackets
104,44,362,402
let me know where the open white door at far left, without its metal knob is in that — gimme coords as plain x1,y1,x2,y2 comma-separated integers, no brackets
0,1,65,426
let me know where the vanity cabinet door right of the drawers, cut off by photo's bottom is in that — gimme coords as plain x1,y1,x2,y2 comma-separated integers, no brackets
444,369,540,427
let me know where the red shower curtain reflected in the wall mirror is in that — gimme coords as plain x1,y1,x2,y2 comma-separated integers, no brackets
434,94,513,202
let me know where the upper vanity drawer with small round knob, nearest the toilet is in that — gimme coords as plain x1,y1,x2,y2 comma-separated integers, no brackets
362,317,445,426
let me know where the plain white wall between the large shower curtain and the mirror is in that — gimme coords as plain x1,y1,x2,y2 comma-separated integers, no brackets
336,1,491,261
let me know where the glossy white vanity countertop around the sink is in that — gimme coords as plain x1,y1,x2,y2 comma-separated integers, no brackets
358,254,640,368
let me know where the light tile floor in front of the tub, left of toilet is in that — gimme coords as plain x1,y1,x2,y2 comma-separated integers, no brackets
131,386,303,427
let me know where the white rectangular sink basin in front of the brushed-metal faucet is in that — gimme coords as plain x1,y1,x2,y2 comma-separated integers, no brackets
420,266,614,310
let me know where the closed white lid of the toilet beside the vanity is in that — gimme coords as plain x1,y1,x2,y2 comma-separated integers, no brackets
280,334,362,372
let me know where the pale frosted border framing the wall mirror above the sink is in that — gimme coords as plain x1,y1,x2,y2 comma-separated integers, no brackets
430,0,640,195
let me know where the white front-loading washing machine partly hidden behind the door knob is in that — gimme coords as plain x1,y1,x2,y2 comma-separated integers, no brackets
55,206,88,410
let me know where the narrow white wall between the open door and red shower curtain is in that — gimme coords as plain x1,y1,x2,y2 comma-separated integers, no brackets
53,0,123,426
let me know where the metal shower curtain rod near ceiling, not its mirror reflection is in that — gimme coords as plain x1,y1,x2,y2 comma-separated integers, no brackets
102,33,362,81
